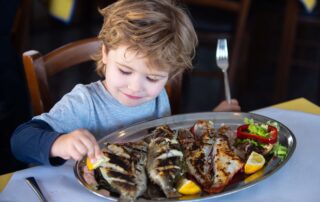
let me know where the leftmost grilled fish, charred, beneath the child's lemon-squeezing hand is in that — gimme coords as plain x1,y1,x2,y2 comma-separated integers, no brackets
98,141,148,201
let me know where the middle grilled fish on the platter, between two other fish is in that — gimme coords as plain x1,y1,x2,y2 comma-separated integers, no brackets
147,126,185,198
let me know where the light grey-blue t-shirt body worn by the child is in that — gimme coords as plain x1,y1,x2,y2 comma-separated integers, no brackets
33,81,171,140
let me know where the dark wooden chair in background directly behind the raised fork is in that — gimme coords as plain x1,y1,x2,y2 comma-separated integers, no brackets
184,0,251,96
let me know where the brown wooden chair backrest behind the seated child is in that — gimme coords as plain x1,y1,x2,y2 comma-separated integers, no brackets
23,38,182,115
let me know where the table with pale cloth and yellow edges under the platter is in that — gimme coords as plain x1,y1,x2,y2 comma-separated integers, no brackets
0,98,320,202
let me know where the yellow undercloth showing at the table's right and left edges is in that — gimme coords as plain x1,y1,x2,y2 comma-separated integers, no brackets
0,98,320,192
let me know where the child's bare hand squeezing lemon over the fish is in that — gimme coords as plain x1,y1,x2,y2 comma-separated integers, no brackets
51,129,102,161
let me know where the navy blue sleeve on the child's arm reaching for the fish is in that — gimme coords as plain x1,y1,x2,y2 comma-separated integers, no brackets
11,120,65,165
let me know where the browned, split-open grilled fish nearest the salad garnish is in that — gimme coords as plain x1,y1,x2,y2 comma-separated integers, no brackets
178,121,243,193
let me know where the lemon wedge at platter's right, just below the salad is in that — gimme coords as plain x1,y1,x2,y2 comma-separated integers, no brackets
244,151,266,174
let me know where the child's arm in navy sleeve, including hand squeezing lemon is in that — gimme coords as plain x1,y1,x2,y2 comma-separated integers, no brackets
11,120,102,165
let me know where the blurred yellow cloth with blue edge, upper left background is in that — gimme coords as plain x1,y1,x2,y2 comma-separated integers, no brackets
49,0,76,23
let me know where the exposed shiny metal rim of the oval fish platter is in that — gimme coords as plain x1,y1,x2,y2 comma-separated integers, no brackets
74,112,296,201
